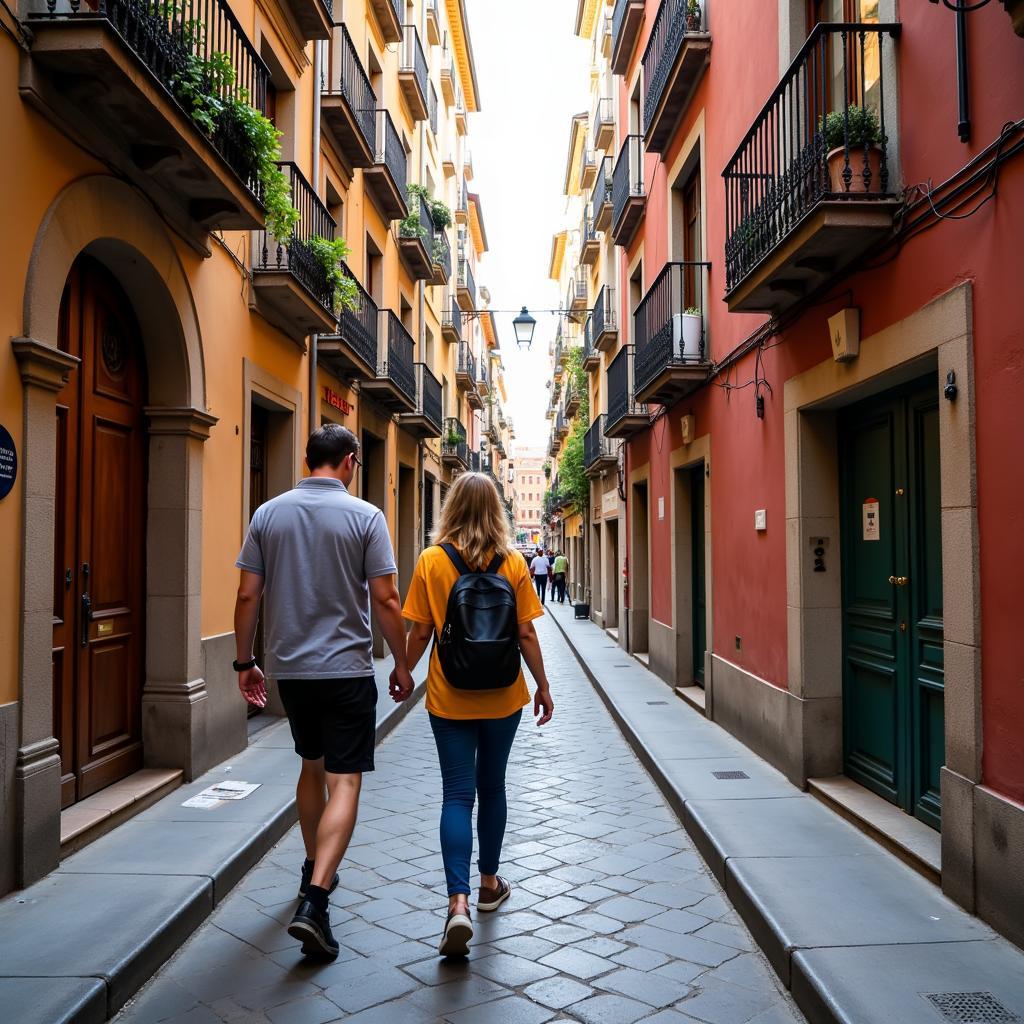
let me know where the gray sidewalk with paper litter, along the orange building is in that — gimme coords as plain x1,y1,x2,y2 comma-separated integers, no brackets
0,659,426,1024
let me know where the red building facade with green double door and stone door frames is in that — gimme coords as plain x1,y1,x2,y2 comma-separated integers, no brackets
590,0,1024,943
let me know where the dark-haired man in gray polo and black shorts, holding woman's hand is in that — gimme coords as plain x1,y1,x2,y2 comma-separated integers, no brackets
234,424,414,958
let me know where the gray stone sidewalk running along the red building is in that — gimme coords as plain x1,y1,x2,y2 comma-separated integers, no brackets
547,603,1024,1024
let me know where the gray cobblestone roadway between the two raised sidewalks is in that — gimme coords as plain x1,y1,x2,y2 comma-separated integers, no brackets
118,620,803,1024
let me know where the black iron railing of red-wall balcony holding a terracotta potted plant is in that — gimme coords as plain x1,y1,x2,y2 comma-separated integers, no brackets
722,23,900,296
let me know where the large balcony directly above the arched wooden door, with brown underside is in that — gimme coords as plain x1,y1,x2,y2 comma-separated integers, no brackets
24,0,272,249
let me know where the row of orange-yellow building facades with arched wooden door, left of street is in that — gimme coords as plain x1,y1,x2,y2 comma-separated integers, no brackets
0,0,497,892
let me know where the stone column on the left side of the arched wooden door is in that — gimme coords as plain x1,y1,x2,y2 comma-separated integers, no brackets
11,338,79,886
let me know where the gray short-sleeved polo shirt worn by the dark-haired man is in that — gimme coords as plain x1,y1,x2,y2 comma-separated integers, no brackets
234,476,398,679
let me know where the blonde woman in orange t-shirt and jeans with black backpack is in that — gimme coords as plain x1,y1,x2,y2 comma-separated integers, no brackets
403,473,555,956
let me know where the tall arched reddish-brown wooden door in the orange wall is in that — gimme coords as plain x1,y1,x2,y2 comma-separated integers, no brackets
53,257,146,806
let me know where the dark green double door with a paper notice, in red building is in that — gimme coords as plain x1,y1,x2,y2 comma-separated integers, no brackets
840,378,945,828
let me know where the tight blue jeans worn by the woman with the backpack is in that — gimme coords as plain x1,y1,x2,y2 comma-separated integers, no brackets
430,708,522,896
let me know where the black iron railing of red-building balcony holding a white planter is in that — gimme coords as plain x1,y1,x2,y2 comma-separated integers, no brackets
633,263,711,391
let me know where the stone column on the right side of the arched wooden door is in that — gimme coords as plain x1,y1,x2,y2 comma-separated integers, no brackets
142,408,217,780
